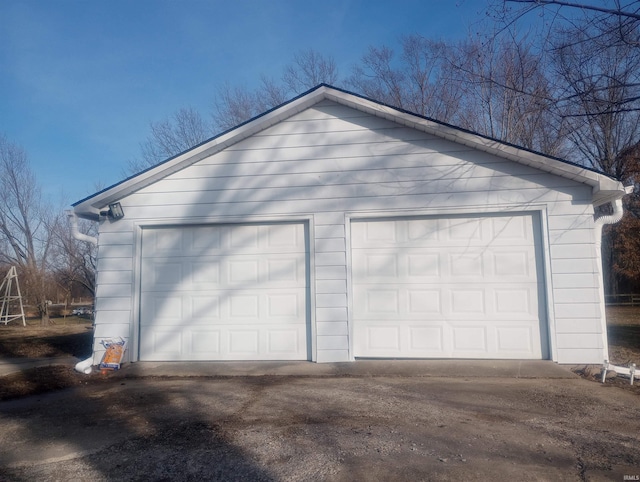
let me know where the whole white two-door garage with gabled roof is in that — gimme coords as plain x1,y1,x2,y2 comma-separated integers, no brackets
74,85,625,364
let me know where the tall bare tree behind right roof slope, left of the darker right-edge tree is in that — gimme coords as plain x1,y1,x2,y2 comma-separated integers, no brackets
450,38,567,156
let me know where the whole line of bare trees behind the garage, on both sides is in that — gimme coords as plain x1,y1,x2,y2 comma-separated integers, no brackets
0,0,640,320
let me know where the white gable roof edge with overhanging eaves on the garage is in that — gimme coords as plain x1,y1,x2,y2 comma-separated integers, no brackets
73,84,625,219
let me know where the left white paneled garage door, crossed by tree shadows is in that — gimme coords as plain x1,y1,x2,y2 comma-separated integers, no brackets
140,223,308,360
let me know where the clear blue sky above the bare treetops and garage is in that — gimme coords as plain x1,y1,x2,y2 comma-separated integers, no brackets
0,0,488,203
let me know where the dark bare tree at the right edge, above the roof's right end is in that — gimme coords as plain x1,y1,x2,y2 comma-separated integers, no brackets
552,15,640,180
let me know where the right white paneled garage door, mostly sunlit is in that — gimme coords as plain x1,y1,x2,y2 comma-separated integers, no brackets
351,214,547,359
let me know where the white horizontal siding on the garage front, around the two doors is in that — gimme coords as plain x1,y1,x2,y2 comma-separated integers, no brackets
96,101,603,363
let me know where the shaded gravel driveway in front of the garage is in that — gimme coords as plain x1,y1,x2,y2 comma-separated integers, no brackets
0,368,640,481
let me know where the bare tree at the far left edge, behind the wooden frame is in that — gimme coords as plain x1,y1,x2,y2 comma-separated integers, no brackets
0,136,60,325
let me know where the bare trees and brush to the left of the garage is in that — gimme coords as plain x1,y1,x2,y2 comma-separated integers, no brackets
0,135,96,325
